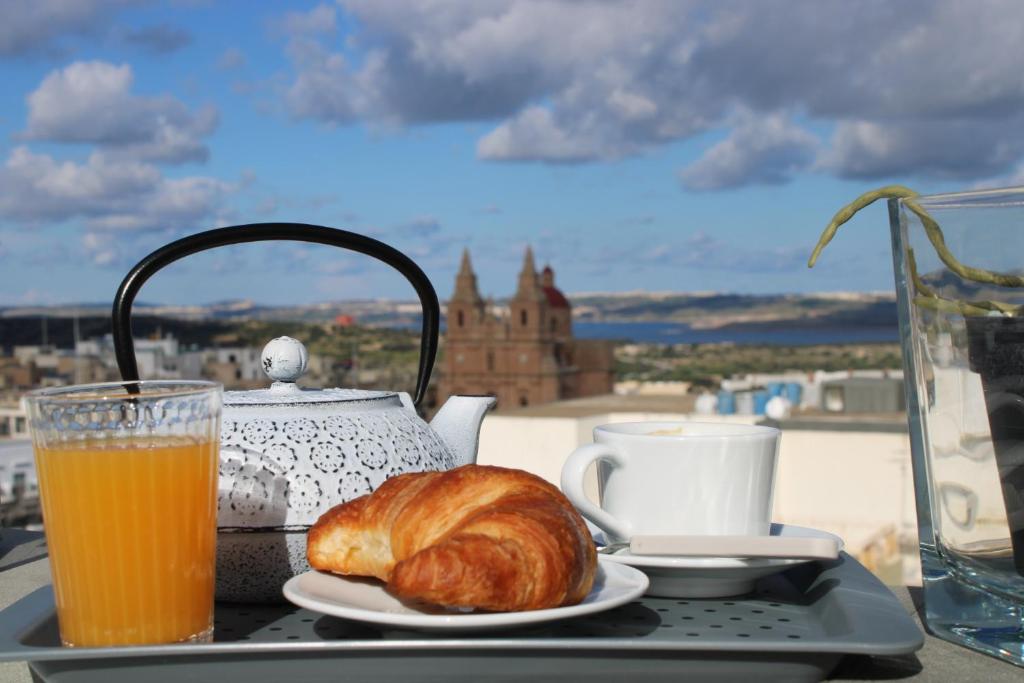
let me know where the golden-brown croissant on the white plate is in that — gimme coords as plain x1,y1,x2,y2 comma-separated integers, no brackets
306,465,597,611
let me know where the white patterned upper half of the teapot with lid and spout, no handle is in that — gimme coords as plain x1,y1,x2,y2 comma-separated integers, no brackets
218,337,495,531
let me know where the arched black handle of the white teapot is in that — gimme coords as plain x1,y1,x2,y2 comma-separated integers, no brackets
113,223,440,405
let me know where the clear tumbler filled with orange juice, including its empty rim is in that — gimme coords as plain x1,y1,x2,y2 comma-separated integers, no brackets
27,381,221,647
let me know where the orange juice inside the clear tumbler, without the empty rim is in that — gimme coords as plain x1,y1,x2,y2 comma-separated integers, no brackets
36,436,218,646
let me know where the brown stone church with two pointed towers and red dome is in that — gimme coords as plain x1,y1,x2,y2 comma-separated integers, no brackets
441,247,614,409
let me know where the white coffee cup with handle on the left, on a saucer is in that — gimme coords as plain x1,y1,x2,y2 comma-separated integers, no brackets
561,422,779,541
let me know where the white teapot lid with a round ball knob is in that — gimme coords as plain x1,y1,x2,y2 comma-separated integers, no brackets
224,337,397,405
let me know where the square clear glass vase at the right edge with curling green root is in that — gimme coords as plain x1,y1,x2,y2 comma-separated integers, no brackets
889,187,1024,665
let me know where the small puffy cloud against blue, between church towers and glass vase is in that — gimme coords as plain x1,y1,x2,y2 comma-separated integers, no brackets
679,114,819,189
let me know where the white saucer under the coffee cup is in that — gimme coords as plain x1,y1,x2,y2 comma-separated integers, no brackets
594,524,843,598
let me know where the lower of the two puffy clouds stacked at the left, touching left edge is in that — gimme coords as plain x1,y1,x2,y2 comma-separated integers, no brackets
0,146,237,232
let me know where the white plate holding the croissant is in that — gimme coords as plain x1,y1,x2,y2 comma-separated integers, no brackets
284,557,648,631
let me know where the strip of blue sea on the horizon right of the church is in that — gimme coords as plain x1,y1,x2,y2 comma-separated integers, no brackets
572,321,899,346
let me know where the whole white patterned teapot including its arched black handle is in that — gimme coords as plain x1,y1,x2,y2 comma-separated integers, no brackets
113,223,495,602
